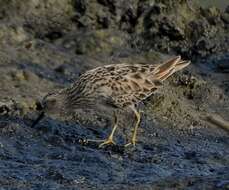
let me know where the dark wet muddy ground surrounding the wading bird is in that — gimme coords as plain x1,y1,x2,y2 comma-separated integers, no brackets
0,0,229,190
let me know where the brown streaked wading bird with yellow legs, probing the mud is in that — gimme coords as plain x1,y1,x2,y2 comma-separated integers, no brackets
33,56,190,147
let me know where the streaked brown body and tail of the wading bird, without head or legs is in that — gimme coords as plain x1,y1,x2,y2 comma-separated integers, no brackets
65,56,189,107
